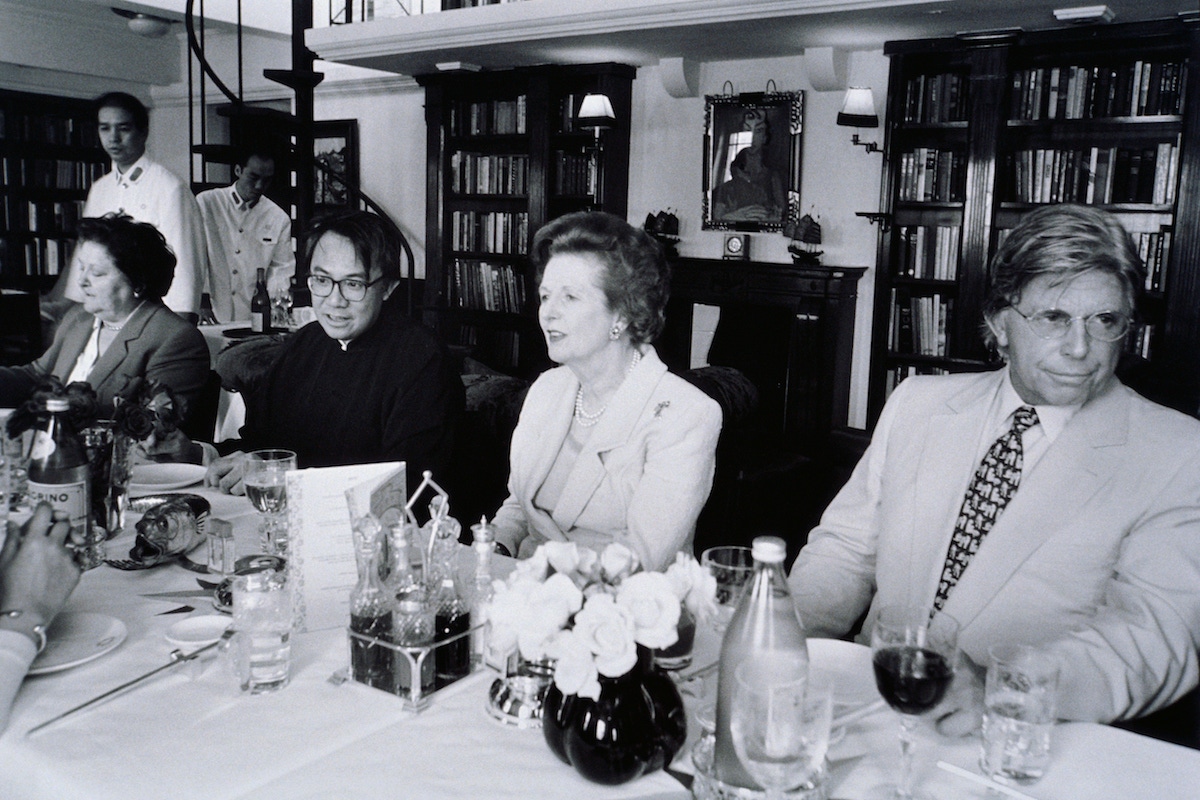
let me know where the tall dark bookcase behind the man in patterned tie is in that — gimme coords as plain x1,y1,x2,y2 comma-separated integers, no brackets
869,18,1200,421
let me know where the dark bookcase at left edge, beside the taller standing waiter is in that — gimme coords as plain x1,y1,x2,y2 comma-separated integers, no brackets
0,90,108,290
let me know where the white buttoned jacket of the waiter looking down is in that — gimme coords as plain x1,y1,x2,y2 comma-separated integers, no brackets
196,186,296,323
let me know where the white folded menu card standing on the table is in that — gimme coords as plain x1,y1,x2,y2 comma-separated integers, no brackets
287,462,407,631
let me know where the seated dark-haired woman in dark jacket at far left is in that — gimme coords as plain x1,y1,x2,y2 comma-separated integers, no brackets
0,213,209,414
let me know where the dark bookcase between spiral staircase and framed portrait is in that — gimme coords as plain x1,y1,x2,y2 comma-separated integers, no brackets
416,64,635,377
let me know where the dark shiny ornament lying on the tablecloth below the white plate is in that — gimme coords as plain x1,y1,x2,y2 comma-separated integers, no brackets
108,494,212,572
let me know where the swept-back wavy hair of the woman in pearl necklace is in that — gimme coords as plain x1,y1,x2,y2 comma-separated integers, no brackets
532,211,671,344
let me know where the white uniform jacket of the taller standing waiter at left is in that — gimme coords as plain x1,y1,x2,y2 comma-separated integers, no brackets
66,156,205,314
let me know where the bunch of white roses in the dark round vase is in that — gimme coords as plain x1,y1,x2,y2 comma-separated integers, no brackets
488,542,716,699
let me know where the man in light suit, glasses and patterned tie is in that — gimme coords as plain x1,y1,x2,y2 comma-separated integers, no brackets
791,205,1200,733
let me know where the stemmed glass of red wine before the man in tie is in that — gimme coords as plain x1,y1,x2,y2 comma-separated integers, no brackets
871,606,959,800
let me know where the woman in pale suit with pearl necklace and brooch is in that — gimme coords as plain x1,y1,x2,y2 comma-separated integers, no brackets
494,212,721,570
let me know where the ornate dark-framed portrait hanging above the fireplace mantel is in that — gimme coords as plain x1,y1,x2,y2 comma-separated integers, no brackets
702,91,804,231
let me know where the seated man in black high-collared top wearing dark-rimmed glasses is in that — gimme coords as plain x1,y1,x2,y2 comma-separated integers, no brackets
165,210,463,494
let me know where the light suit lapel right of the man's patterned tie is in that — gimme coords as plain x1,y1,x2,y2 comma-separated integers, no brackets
946,384,1129,628
